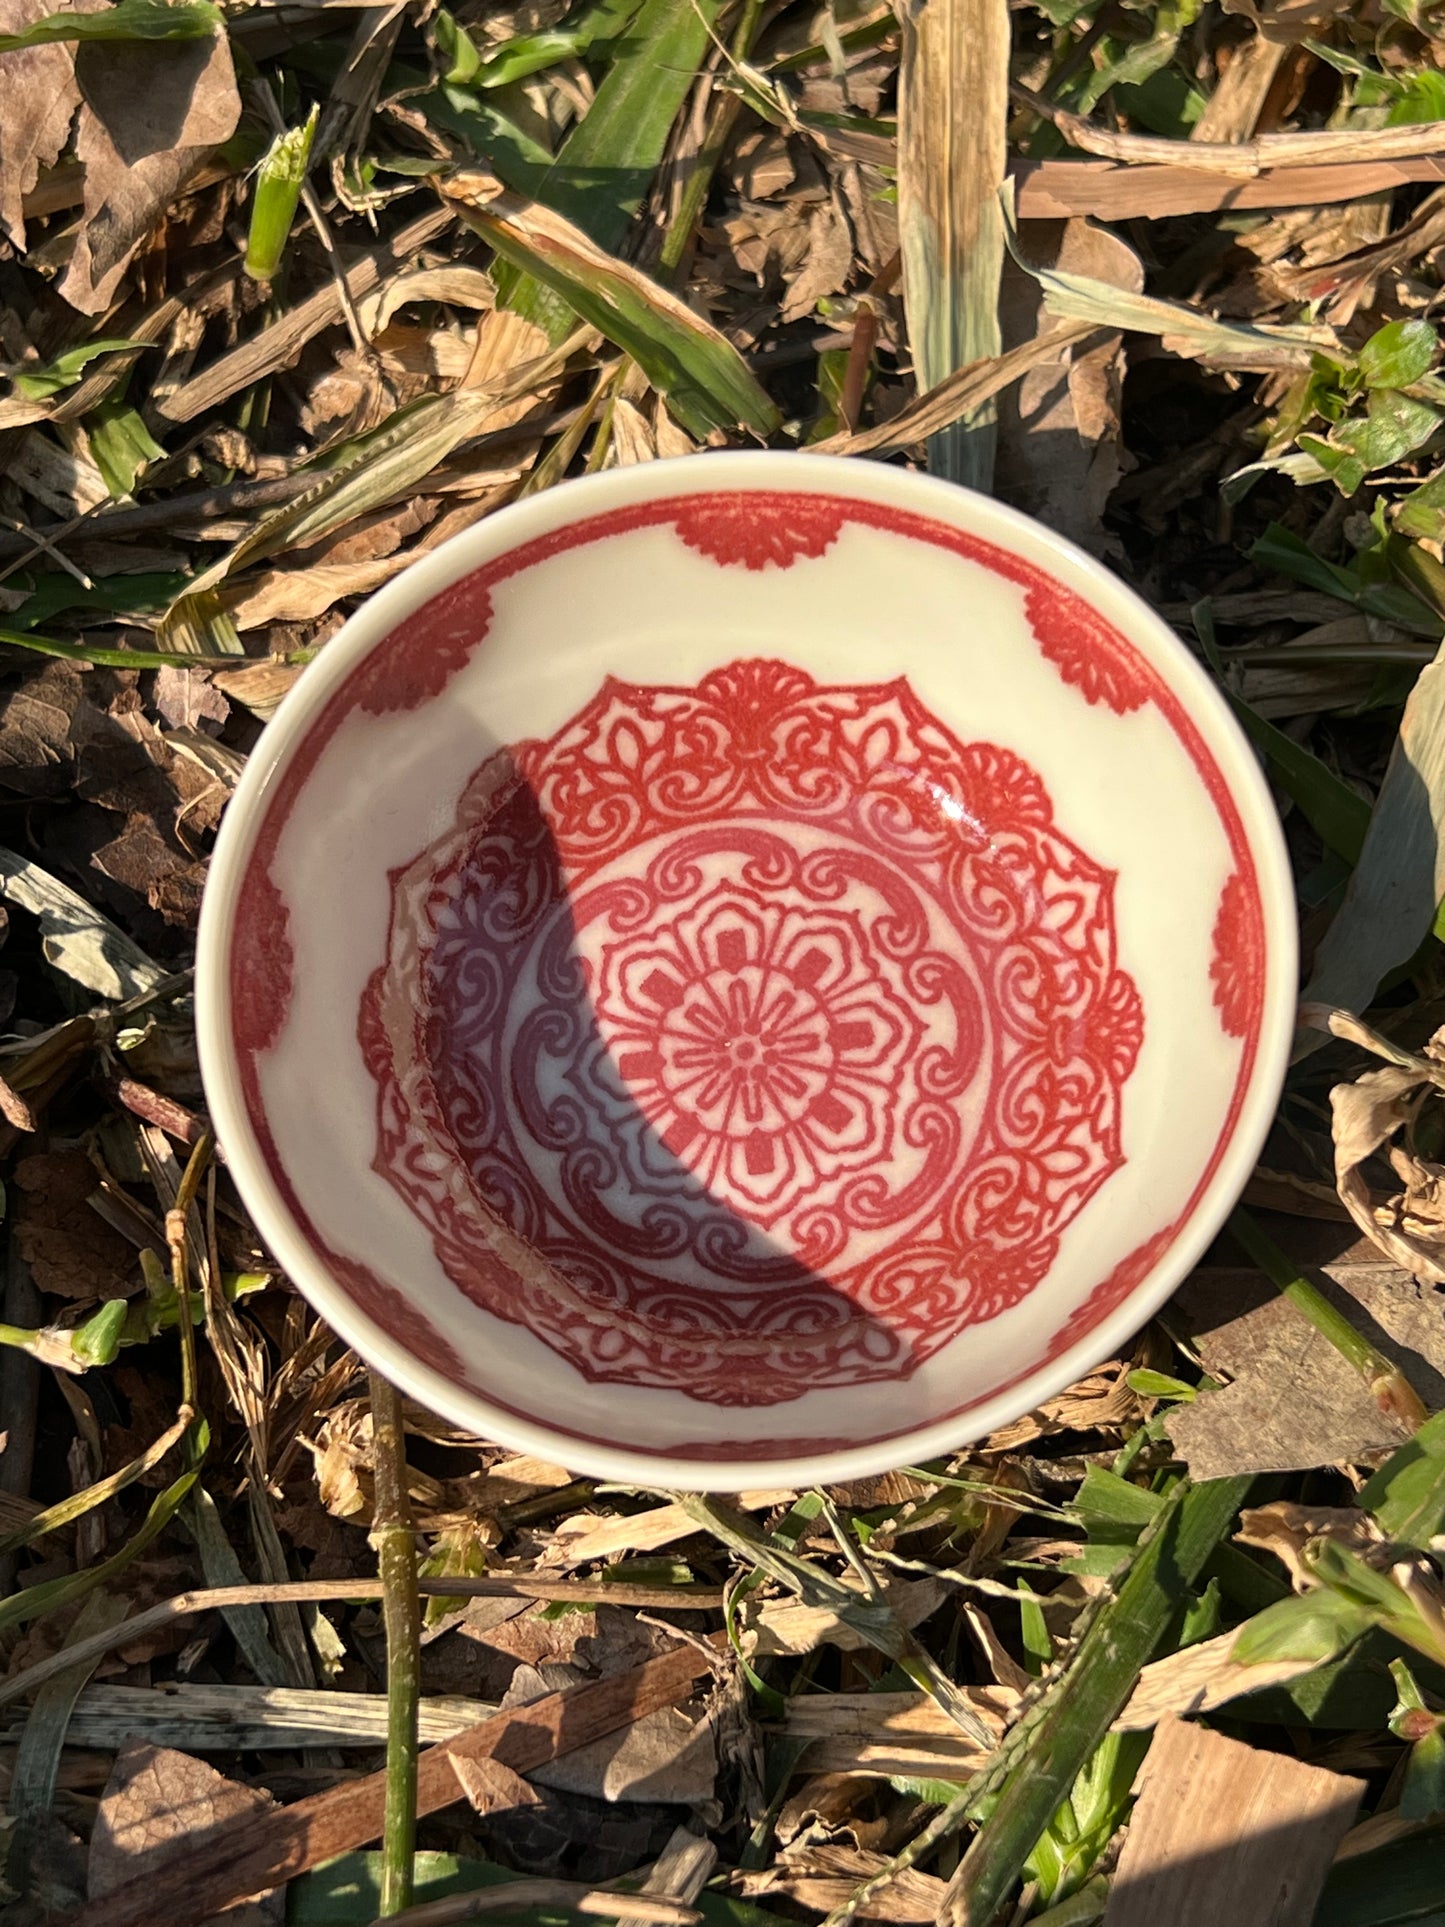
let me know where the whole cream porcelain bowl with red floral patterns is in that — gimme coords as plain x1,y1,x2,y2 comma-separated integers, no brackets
198,453,1295,1490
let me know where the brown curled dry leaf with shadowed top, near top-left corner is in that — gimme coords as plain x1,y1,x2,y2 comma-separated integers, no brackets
58,33,241,314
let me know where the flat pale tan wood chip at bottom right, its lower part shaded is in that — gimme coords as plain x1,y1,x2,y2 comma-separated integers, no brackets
1104,1719,1364,1927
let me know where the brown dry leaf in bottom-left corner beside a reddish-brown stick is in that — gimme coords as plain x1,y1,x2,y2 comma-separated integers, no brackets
87,1740,285,1927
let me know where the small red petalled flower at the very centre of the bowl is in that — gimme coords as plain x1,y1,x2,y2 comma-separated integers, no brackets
586,884,921,1226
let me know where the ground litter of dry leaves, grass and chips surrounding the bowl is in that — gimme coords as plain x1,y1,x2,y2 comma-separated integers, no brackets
0,0,1445,1927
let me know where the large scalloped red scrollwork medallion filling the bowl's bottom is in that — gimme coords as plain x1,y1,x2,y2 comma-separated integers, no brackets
358,661,1143,1405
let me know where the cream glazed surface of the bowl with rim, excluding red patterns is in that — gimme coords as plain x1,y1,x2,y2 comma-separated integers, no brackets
198,455,1295,1490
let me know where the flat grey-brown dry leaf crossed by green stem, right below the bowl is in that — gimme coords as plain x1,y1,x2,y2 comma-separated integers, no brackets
1168,1264,1445,1478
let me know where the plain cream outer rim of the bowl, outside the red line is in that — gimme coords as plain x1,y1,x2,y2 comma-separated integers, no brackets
195,451,1297,1491
